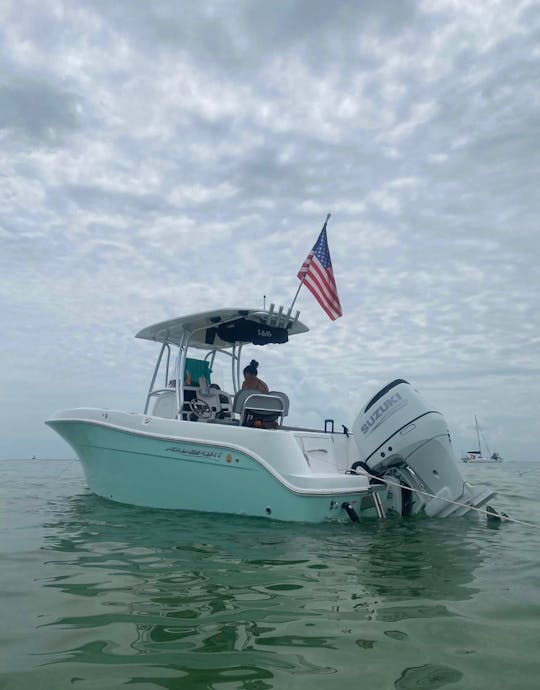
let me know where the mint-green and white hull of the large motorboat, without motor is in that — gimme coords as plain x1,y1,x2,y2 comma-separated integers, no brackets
47,409,386,523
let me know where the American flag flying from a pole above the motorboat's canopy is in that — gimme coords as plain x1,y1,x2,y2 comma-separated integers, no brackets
298,218,343,321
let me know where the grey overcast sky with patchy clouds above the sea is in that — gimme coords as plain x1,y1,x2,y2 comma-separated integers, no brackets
0,0,540,460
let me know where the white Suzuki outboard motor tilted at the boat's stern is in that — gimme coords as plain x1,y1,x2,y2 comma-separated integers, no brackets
353,379,494,517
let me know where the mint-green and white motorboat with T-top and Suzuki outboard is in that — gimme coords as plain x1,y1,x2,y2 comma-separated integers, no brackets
46,304,494,523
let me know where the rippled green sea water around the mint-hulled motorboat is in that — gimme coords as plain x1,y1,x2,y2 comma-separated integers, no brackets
0,460,540,690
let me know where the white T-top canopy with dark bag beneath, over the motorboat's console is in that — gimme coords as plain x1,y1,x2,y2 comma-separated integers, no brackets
135,308,309,350
